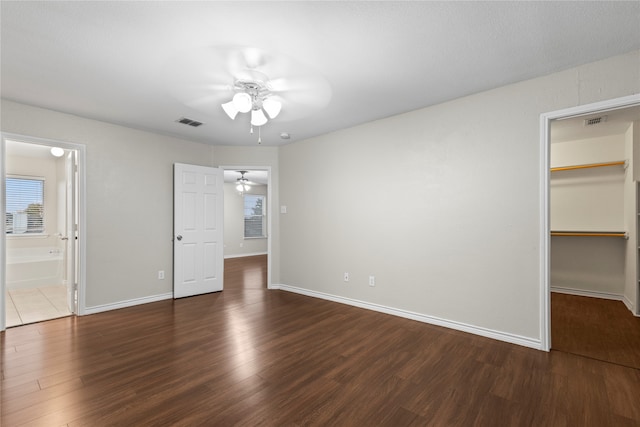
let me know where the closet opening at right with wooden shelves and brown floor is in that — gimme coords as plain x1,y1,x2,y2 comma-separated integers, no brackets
548,102,640,369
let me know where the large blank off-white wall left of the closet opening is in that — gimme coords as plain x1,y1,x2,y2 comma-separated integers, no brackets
279,51,640,345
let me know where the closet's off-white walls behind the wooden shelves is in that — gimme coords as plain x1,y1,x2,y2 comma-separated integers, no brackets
550,134,636,299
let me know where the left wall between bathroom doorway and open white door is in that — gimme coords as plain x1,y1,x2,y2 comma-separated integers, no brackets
1,100,213,310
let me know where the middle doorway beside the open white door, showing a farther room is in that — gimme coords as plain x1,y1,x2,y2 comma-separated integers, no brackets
220,166,273,288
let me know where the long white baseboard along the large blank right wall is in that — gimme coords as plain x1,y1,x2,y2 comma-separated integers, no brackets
270,284,542,350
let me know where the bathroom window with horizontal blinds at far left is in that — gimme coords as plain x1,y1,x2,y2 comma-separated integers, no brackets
5,177,44,234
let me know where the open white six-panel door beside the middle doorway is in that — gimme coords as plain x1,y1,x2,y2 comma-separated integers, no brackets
173,163,224,298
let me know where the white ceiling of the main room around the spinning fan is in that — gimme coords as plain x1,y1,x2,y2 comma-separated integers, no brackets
0,1,640,145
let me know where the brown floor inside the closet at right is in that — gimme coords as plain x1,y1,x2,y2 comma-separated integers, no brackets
551,293,640,369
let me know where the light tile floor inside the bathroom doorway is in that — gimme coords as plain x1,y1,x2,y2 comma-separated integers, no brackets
5,285,71,327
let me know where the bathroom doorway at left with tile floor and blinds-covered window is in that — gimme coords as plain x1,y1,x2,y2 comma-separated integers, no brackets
0,134,84,329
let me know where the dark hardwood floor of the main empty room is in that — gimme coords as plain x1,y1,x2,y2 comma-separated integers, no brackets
1,257,640,427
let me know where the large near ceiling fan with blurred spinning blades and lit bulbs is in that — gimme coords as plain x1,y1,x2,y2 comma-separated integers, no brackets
170,46,332,141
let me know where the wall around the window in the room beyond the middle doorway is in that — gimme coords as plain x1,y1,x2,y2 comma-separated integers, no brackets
224,183,267,258
